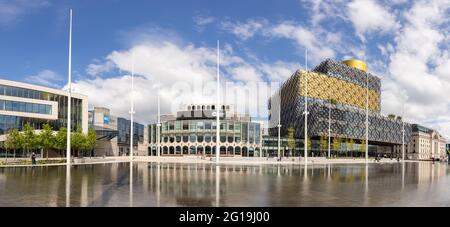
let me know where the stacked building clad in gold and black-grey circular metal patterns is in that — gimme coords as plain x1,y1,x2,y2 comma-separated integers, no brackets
269,59,411,146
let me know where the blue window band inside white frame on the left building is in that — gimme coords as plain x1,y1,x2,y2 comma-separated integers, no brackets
0,100,52,115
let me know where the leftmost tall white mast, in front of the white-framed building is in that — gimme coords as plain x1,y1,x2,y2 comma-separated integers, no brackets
66,9,72,165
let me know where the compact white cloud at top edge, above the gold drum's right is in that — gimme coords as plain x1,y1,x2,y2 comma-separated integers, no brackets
348,0,398,40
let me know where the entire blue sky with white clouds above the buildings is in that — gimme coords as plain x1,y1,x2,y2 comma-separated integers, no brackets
0,0,450,138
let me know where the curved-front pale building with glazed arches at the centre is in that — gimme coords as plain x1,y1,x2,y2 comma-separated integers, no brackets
148,105,262,157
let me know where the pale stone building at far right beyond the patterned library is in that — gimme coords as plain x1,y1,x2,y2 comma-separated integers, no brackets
407,124,446,160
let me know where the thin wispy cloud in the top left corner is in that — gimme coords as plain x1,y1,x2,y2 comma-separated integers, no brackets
0,0,50,26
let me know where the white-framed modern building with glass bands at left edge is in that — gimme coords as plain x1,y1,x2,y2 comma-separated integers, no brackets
0,79,88,141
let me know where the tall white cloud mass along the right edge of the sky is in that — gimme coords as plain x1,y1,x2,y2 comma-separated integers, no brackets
382,1,450,138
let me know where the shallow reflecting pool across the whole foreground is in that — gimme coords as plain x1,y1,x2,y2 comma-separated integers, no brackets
0,162,450,206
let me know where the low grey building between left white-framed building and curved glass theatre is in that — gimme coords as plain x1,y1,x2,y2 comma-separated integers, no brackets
89,107,147,156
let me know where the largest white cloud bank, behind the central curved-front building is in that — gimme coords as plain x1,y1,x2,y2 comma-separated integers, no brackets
73,36,293,123
